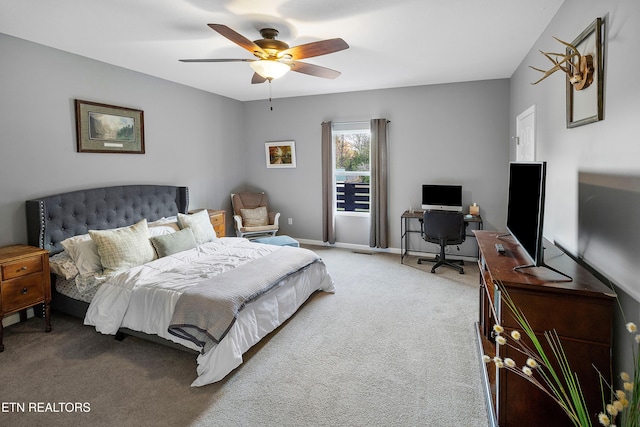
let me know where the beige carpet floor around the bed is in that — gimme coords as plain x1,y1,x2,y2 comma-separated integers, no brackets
0,247,488,427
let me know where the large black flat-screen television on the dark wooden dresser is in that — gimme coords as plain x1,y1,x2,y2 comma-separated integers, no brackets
507,162,571,279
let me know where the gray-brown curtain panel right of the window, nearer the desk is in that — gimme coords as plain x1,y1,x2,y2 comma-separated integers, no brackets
370,119,389,248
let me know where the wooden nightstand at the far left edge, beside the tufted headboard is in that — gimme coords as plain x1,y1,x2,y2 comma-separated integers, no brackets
0,245,51,351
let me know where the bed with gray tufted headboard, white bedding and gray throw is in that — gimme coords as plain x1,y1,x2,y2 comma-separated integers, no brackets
26,185,335,386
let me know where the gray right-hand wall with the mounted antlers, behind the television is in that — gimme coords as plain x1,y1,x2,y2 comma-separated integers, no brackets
510,0,640,384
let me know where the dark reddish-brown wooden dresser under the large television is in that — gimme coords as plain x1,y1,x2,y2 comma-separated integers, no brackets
475,231,615,427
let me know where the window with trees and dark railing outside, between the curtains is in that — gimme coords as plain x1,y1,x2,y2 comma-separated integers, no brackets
332,122,371,215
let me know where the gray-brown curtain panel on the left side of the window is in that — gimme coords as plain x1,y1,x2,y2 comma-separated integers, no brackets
322,122,336,244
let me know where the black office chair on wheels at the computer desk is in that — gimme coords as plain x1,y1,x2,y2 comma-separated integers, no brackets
418,210,467,274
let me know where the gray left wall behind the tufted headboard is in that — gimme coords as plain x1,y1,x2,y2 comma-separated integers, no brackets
0,34,244,245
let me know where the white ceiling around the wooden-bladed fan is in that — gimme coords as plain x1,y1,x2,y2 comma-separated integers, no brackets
0,0,564,101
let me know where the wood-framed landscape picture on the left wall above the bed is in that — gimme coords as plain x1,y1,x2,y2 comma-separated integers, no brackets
75,99,144,154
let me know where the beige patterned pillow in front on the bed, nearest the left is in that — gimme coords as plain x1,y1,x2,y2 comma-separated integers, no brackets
89,219,156,274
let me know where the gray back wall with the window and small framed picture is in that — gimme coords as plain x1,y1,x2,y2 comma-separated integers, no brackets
244,80,509,248
